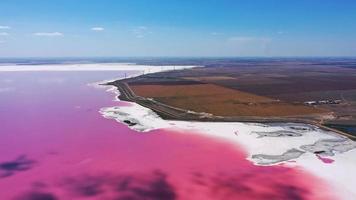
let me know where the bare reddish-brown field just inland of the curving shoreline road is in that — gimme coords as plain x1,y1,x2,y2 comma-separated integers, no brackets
130,84,325,116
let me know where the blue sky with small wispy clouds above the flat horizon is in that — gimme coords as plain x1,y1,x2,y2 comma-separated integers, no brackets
0,0,356,57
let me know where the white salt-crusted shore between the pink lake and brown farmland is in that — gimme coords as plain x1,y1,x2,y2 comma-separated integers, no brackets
94,63,356,199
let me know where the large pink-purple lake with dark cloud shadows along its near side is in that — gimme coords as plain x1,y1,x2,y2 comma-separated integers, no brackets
0,72,334,200
